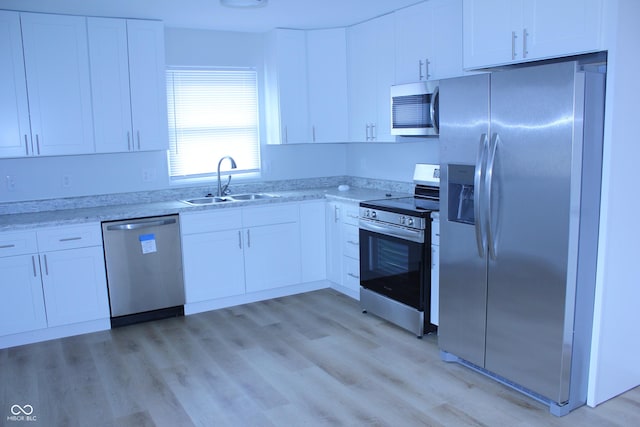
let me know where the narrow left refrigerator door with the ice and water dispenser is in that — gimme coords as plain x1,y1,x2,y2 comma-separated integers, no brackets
438,74,489,366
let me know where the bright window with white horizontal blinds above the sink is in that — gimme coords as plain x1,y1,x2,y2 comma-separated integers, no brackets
167,68,260,179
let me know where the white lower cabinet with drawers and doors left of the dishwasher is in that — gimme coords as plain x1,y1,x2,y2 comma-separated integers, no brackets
0,224,109,347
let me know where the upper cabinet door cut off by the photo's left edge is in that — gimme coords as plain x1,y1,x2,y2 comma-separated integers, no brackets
0,11,31,157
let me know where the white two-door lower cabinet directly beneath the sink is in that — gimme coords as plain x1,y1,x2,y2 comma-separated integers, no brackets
180,203,302,304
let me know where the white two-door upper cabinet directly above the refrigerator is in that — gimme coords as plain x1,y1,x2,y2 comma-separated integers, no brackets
463,0,603,69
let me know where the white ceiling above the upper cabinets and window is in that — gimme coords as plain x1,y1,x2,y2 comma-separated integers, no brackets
0,0,421,32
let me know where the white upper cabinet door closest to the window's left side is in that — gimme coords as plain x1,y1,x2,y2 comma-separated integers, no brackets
127,19,169,150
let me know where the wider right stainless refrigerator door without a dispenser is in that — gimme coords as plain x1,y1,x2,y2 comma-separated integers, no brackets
482,63,581,402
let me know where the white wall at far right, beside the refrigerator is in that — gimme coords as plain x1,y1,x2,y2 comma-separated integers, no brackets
587,0,640,406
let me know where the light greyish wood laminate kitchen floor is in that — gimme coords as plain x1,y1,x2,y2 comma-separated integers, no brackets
0,289,640,427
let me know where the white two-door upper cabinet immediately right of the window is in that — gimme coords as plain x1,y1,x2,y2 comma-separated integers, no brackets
266,28,348,144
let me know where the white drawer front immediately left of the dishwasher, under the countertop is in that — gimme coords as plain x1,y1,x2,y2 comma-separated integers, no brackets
37,223,102,252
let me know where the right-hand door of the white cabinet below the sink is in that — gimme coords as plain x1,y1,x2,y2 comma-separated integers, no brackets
245,222,301,292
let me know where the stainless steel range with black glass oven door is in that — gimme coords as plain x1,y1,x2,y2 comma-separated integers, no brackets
359,164,440,337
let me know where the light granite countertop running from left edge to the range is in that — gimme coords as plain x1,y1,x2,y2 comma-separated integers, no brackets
0,186,409,232
